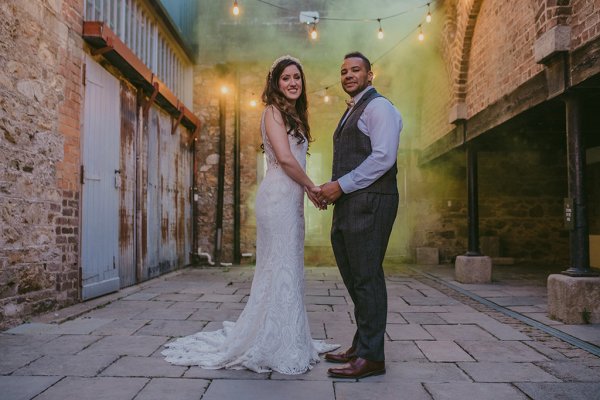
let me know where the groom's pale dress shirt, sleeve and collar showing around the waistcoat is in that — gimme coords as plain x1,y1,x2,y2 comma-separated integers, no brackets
338,86,402,193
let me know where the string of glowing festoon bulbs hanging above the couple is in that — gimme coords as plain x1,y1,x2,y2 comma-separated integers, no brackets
231,0,436,107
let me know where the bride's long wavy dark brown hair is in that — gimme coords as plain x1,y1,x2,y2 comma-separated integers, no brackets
262,58,313,143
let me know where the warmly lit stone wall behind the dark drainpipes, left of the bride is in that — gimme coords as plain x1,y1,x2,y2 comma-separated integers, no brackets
194,66,264,262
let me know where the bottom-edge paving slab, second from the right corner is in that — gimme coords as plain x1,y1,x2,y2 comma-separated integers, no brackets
425,383,528,400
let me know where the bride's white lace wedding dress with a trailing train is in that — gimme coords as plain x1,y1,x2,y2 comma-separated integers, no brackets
162,112,339,375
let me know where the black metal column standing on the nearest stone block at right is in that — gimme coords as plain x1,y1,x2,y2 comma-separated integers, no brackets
562,94,597,276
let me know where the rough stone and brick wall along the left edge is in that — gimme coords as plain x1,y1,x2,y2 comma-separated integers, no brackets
0,0,83,328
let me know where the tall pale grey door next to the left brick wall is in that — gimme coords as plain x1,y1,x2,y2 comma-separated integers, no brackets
81,56,121,299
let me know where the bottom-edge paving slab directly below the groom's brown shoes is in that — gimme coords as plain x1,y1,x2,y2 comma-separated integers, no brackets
334,379,432,400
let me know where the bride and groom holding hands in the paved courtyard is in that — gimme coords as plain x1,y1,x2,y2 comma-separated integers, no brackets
162,52,402,379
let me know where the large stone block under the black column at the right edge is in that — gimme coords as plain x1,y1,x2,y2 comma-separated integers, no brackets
548,274,600,324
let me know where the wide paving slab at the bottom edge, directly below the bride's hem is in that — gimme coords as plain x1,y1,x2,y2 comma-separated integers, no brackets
202,380,334,400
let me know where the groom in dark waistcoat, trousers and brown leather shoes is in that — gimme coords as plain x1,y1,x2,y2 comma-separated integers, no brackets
316,52,402,379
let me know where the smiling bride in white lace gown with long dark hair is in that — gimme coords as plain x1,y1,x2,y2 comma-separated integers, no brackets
162,56,339,375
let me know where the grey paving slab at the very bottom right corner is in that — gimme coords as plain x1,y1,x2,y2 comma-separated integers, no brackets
515,382,600,400
